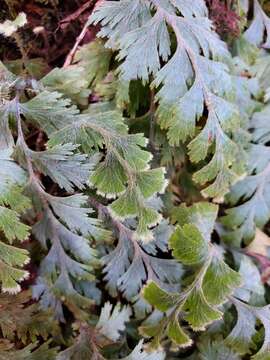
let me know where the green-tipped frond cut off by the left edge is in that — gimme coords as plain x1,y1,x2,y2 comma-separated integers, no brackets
0,148,30,293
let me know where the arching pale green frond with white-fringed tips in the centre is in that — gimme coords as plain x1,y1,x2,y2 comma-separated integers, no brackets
42,102,167,241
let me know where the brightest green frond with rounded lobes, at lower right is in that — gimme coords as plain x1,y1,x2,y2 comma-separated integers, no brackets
141,203,241,347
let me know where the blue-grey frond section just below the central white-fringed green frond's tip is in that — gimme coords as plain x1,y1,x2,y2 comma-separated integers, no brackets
102,215,182,317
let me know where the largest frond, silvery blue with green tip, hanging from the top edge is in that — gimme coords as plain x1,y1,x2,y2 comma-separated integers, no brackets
89,0,243,197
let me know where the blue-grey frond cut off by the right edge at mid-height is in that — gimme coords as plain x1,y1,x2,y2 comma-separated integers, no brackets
222,106,270,243
